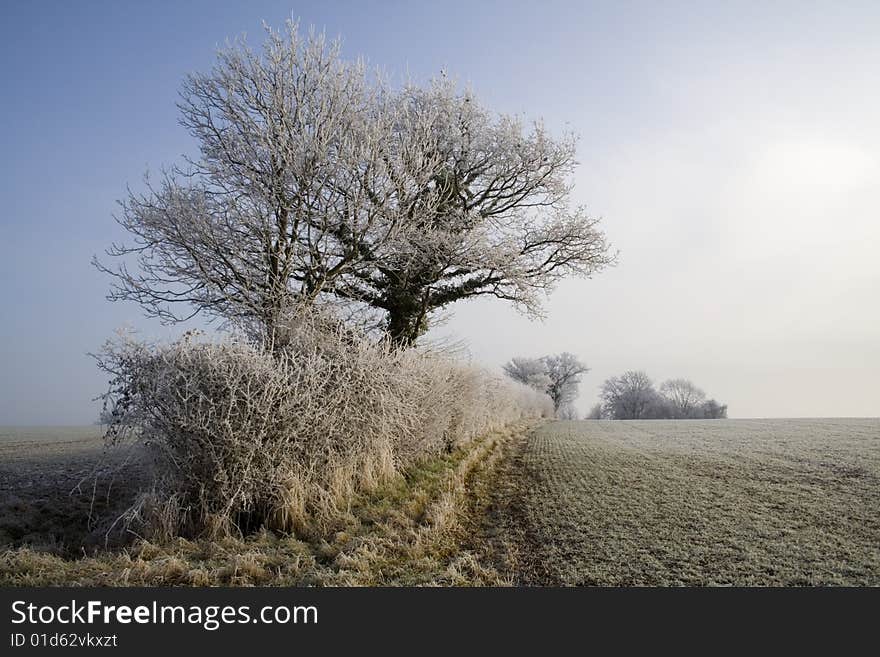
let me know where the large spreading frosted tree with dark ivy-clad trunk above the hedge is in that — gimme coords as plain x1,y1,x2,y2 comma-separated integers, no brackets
334,78,614,344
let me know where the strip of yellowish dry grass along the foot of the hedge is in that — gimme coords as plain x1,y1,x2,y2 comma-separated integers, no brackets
0,425,525,586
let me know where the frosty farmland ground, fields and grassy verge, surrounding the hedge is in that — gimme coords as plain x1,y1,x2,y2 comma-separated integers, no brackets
0,419,880,586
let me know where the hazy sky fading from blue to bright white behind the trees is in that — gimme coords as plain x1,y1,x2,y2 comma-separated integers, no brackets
0,0,880,424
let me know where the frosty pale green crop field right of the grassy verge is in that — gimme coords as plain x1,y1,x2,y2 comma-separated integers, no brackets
502,419,880,585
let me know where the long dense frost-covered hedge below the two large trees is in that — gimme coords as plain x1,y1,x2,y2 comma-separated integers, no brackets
98,312,553,535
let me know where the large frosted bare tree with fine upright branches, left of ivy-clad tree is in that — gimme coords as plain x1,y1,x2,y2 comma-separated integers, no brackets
95,23,439,344
